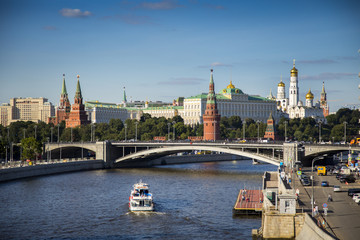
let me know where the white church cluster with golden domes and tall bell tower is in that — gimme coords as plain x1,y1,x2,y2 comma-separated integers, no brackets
276,60,329,121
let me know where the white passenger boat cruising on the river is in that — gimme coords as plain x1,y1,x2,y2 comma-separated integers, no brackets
129,180,154,212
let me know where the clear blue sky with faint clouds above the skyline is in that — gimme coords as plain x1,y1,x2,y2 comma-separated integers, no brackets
0,0,360,111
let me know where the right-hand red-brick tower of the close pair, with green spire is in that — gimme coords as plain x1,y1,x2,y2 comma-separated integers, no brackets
66,75,90,128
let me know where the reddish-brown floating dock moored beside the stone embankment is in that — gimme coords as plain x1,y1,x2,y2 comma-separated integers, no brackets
233,189,264,215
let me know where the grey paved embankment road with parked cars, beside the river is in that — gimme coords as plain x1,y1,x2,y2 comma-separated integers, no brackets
295,168,360,240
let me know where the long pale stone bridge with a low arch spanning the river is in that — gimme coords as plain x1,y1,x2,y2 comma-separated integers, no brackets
45,141,360,167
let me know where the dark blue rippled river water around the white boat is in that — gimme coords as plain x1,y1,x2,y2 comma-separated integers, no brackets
0,160,276,239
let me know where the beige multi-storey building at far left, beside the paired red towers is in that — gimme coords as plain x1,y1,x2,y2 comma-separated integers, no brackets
0,97,55,126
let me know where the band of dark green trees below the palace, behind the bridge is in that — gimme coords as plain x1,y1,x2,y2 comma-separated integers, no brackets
0,108,360,159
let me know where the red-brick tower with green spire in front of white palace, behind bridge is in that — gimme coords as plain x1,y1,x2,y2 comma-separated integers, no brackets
203,69,220,141
